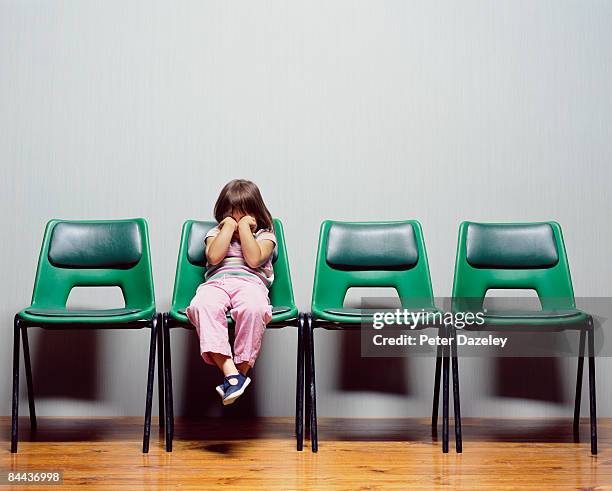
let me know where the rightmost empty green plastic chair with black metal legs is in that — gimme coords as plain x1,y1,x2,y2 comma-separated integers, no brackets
453,222,597,454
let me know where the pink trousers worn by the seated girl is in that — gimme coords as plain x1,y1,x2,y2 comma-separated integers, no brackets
187,275,272,366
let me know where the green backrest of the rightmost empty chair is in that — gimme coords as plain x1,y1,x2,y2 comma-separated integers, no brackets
453,222,575,309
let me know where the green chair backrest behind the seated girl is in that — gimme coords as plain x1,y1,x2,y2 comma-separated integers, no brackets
172,218,295,312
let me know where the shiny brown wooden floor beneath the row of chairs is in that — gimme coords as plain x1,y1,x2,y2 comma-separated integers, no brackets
0,418,612,490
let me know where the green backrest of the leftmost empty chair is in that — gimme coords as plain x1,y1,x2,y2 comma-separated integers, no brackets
32,218,155,310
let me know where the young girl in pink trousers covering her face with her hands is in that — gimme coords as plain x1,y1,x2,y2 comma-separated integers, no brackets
187,179,276,405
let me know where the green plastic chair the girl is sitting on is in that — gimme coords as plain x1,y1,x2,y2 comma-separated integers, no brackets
162,218,304,452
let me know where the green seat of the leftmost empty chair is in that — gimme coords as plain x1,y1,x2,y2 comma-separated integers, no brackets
19,307,155,324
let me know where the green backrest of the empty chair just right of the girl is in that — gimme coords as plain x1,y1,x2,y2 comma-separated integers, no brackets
312,220,433,313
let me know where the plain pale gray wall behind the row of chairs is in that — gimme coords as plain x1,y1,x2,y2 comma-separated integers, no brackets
0,0,612,416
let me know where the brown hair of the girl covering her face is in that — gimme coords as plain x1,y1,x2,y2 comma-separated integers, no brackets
215,179,274,230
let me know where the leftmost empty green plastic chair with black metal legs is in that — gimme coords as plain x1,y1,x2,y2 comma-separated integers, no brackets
11,218,164,453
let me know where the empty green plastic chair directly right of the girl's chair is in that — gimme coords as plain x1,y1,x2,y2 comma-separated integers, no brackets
306,220,461,452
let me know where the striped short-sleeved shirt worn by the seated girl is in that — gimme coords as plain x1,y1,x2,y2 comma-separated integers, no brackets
204,225,277,288
